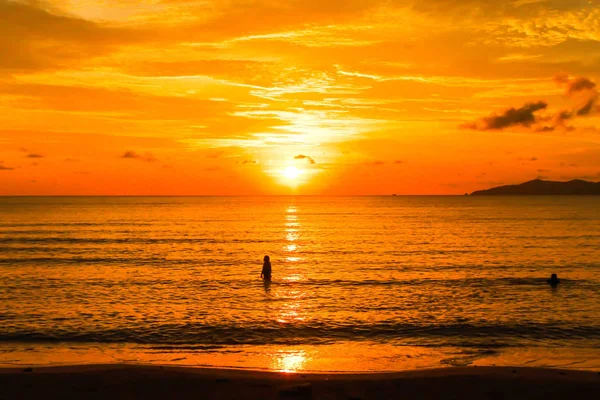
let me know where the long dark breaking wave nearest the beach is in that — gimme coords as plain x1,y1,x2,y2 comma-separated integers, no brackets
0,322,600,347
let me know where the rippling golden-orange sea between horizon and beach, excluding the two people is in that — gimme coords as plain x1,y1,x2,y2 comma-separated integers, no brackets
0,196,600,372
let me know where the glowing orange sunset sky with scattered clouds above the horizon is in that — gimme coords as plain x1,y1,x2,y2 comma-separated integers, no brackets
0,0,600,195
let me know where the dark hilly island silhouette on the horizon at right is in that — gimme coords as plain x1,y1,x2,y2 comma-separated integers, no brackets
471,179,600,196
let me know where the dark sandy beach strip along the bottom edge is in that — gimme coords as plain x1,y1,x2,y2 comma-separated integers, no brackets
0,365,600,400
